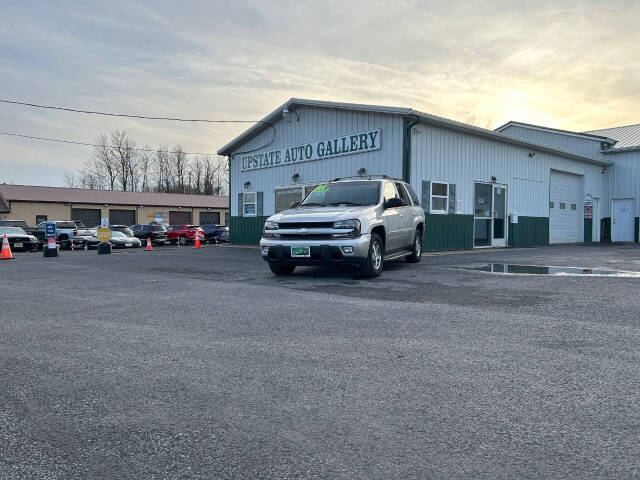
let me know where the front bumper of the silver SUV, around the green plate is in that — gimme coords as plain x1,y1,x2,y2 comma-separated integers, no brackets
260,234,371,265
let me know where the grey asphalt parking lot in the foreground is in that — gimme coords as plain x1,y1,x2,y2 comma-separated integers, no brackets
0,245,640,479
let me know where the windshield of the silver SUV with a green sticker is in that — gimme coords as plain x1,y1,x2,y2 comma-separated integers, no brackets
300,181,380,207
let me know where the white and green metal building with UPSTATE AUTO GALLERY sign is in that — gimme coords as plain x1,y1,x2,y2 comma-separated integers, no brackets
218,99,637,250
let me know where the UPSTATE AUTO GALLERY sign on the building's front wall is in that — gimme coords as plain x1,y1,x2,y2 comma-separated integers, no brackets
240,129,381,172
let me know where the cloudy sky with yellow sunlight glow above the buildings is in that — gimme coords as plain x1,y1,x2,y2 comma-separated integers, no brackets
0,0,640,185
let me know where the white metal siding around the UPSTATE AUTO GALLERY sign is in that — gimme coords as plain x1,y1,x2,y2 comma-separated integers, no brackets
230,107,403,216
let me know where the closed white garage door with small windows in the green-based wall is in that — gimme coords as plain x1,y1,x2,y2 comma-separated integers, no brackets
549,171,584,243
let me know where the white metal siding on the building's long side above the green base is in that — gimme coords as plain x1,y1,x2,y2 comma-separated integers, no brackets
411,124,604,226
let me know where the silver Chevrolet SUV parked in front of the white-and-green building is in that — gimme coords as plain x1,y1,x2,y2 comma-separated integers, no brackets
260,176,424,278
